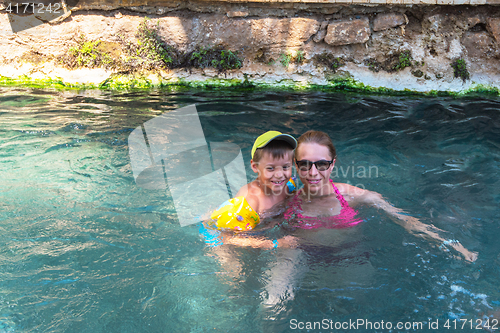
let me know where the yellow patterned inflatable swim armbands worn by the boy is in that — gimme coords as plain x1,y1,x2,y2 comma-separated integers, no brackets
210,178,296,231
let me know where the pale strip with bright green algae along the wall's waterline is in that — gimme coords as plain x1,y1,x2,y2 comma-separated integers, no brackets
0,64,500,96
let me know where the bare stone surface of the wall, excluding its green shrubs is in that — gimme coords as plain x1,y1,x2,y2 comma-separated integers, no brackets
0,5,500,91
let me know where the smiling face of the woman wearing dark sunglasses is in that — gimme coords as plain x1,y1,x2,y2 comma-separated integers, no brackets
296,142,335,195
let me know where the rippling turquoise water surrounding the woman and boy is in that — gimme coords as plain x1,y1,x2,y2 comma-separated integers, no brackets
0,88,500,332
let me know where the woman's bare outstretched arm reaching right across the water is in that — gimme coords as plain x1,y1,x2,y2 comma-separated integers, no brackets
337,184,477,262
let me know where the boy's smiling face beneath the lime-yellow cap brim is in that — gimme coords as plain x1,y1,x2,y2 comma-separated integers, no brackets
250,152,293,194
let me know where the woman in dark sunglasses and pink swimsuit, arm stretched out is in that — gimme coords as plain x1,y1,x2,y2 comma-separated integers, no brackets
285,131,477,262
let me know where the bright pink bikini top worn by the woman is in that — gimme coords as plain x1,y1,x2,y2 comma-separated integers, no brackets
285,179,363,229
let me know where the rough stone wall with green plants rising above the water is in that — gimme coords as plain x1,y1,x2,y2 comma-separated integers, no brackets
0,1,500,92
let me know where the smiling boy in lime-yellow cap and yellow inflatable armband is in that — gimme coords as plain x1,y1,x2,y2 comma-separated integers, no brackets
211,131,297,230
